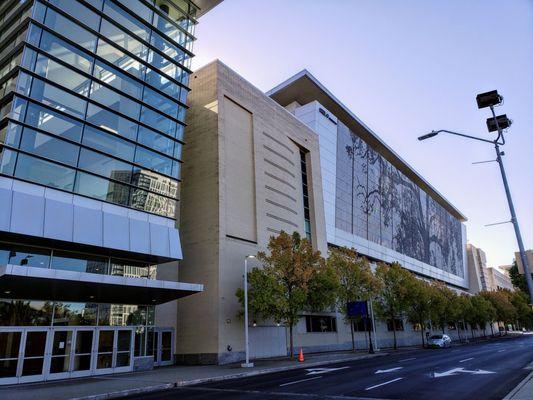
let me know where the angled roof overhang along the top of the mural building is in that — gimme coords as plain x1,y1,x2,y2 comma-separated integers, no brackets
266,69,467,222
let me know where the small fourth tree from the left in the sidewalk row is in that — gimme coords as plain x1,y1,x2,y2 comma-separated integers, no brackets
406,274,431,347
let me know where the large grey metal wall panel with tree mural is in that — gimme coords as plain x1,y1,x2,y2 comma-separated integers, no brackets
335,121,464,277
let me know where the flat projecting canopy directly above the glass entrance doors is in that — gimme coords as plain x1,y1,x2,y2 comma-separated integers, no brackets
0,264,203,305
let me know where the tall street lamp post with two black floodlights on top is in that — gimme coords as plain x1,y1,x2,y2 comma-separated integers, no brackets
418,90,533,304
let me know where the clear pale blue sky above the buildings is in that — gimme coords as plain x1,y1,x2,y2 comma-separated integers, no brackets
193,0,533,266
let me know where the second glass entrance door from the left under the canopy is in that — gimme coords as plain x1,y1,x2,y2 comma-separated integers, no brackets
18,329,48,383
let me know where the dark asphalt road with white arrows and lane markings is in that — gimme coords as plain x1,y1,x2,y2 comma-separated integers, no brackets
123,335,533,400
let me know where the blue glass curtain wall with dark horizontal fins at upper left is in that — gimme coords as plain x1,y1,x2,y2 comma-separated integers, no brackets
0,0,196,218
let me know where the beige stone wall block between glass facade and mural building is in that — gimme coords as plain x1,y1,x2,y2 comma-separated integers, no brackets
176,61,327,362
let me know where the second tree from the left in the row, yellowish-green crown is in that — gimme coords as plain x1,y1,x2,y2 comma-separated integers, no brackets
327,247,381,351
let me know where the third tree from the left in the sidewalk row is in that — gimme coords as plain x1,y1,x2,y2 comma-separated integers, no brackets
375,263,412,349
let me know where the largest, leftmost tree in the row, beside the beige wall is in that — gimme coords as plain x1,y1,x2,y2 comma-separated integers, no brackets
236,232,336,357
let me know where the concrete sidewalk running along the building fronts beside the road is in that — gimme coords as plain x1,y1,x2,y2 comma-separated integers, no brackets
0,352,388,400
